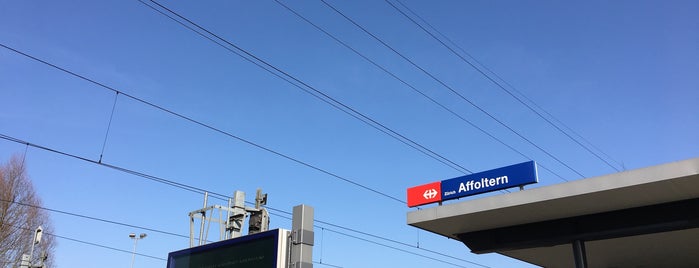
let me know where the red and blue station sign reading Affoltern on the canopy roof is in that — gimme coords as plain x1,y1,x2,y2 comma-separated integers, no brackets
408,161,538,207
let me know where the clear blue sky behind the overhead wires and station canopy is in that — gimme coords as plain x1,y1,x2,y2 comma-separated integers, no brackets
0,0,699,268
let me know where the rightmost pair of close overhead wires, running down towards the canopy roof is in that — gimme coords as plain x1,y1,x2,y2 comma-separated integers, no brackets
384,0,619,172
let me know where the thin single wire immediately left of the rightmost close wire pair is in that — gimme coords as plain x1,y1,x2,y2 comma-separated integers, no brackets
321,0,585,178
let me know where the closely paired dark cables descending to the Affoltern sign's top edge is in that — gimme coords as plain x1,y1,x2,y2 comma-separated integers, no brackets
137,0,471,175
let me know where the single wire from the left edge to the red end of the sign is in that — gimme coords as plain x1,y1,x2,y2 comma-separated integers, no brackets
0,43,406,204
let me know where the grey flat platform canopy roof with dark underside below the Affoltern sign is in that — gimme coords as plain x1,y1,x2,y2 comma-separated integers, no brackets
407,158,699,267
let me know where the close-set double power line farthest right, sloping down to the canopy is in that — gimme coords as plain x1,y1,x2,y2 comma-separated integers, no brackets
384,0,620,171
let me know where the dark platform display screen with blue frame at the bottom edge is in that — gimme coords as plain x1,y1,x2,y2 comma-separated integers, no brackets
167,229,289,268
